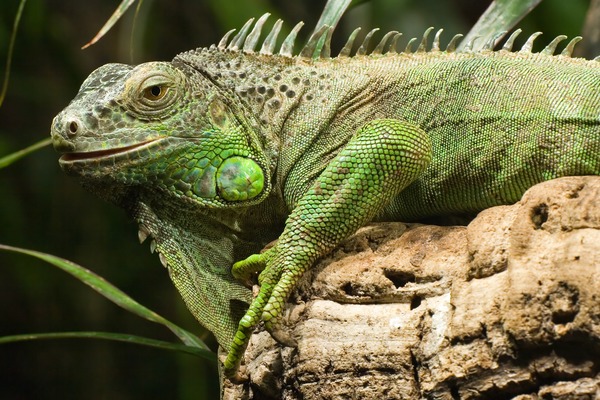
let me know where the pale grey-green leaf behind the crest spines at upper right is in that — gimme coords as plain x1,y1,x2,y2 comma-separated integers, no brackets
457,0,542,51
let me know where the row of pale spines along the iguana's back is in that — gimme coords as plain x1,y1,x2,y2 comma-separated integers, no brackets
211,13,600,61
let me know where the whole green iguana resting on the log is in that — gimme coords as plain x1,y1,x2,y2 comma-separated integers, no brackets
52,15,600,375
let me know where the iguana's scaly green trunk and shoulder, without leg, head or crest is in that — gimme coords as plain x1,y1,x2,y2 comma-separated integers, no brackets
175,27,600,221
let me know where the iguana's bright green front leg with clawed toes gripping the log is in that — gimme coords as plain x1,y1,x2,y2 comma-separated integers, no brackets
224,119,431,376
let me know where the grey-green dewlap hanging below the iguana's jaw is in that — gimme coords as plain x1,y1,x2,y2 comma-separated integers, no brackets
84,182,284,349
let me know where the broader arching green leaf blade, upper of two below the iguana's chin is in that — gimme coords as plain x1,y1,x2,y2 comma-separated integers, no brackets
0,244,208,350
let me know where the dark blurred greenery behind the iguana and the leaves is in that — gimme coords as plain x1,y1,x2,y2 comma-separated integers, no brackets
0,0,589,400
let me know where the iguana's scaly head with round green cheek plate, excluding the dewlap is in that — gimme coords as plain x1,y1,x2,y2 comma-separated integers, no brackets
52,62,270,208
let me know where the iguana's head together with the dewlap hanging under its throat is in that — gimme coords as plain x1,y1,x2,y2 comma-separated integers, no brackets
51,62,271,348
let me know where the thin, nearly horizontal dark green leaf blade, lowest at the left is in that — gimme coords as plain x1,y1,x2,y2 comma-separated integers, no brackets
0,332,217,362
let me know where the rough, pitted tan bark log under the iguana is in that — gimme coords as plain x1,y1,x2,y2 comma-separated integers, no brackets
223,177,600,400
